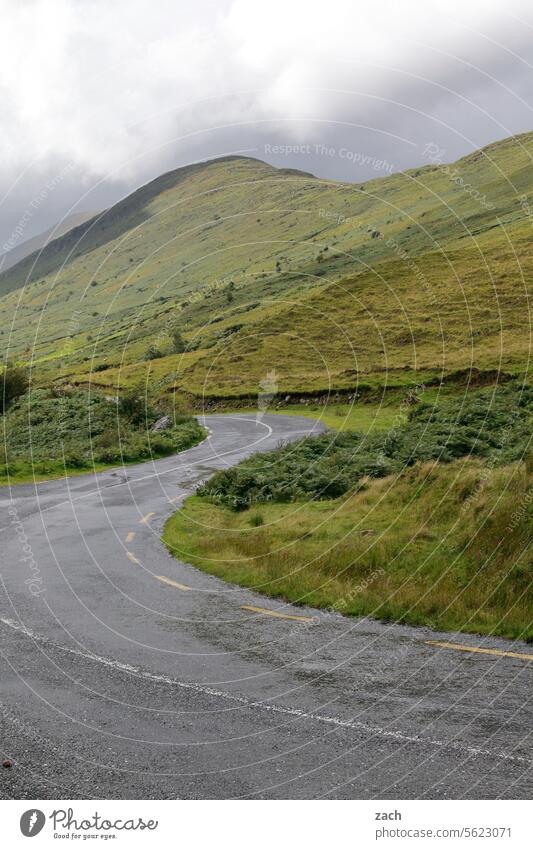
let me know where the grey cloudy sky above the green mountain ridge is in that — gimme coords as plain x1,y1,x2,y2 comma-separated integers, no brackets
0,0,533,252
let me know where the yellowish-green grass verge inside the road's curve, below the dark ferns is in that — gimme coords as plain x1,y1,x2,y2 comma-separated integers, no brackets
163,459,533,640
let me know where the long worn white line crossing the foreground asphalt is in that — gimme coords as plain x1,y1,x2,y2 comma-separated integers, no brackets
0,617,533,766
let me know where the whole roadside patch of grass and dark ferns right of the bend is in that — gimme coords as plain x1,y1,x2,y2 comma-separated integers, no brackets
163,384,533,640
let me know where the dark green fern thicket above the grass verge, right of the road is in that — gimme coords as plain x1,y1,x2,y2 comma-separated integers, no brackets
198,384,533,510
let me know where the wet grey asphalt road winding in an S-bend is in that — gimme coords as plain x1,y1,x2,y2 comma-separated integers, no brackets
0,415,533,799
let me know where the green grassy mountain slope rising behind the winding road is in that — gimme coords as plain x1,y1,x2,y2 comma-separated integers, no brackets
0,134,533,398
